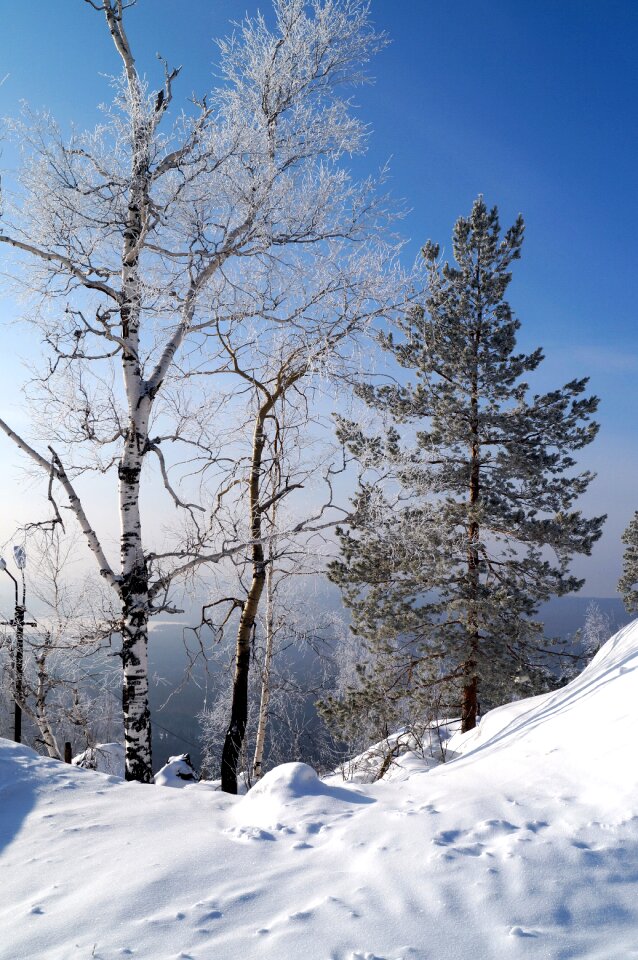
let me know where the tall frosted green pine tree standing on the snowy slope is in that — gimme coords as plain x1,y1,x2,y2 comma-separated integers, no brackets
328,197,605,730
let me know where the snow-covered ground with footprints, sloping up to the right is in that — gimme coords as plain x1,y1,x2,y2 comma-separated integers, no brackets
0,623,638,960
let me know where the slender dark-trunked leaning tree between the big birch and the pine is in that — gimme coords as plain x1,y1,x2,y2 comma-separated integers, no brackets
209,258,406,792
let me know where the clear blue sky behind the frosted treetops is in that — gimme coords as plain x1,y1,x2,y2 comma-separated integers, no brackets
0,0,638,595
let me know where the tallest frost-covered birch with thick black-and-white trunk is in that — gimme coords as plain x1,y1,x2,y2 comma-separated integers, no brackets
0,0,396,782
